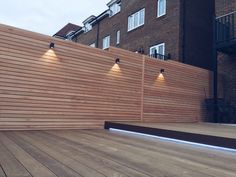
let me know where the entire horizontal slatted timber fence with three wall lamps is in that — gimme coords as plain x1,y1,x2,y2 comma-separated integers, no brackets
0,25,213,130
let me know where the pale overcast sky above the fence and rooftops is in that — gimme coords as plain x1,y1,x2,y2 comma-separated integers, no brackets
0,0,109,35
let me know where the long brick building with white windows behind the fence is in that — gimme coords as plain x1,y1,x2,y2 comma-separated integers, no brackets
55,0,214,69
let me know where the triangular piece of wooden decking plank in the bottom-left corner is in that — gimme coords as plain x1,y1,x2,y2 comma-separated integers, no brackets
0,137,31,177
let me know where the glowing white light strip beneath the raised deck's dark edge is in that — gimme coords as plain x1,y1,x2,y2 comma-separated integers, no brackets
109,128,236,152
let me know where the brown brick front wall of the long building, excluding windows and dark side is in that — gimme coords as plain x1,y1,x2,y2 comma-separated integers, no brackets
76,0,181,59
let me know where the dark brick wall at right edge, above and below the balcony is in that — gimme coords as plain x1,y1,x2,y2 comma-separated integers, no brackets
216,0,236,102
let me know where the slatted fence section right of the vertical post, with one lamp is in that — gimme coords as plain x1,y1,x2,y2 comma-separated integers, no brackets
144,59,212,122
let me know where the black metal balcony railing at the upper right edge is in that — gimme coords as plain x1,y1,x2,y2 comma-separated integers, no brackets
215,12,236,44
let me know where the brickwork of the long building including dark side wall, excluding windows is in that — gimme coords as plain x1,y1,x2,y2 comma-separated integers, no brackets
73,0,214,69
